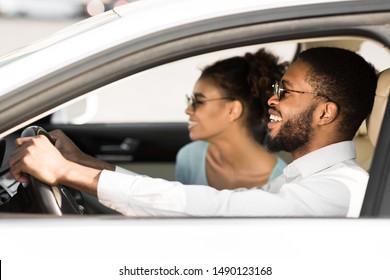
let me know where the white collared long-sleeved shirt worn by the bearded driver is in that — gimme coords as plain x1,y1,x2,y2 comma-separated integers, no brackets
98,141,368,217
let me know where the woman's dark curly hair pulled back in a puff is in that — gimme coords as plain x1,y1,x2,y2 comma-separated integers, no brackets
200,49,288,128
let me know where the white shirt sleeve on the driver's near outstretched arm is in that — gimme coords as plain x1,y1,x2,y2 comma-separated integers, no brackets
98,170,316,217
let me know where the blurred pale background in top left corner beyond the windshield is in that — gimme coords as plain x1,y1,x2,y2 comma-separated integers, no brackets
0,0,131,55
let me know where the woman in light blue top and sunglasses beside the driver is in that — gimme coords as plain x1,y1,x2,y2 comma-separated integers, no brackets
176,49,287,189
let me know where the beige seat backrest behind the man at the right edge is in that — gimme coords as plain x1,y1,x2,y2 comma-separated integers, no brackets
367,68,390,147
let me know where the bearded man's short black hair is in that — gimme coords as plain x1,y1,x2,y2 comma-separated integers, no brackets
297,47,377,139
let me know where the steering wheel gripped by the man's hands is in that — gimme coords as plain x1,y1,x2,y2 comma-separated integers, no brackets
21,126,85,216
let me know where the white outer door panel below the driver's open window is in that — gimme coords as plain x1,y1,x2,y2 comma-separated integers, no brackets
0,218,390,280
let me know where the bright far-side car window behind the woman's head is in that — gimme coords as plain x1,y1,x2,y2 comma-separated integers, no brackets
52,42,297,124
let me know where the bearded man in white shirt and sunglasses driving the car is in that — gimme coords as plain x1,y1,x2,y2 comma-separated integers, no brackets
9,47,377,217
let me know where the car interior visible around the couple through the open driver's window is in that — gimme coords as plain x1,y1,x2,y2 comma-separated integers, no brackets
0,34,390,214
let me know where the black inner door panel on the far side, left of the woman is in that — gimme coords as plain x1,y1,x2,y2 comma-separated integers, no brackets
45,123,190,178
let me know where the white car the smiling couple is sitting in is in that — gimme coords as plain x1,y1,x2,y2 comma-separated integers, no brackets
0,0,390,279
